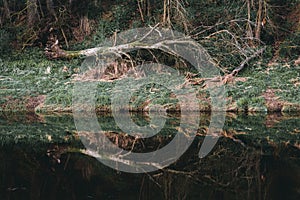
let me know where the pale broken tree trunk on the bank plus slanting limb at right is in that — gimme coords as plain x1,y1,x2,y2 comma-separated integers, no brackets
45,27,266,83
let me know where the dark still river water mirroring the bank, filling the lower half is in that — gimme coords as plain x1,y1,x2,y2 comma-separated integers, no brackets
0,113,300,200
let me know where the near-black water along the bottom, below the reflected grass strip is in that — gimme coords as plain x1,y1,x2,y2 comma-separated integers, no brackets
0,135,300,200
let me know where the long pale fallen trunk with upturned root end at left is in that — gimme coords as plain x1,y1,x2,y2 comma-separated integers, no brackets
45,24,195,59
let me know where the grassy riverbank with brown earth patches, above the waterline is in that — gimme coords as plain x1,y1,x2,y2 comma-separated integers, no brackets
0,48,300,113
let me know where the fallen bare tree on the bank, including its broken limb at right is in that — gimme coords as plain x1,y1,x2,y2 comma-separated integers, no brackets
45,24,266,83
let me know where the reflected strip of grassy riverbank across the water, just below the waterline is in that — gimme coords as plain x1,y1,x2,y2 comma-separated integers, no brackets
0,112,300,148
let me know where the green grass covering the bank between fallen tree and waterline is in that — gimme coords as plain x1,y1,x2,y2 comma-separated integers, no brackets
0,45,300,112
